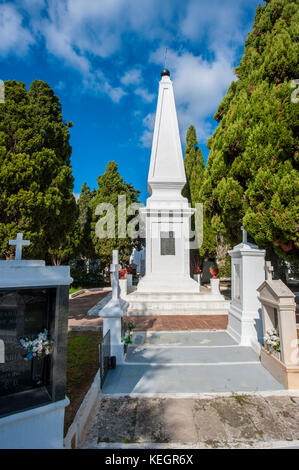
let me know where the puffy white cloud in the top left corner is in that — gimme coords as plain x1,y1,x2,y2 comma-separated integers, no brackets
0,3,34,57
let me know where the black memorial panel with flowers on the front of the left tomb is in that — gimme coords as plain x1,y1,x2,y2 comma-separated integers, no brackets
0,288,56,416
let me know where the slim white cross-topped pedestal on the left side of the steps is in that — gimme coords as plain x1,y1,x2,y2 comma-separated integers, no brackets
99,250,127,364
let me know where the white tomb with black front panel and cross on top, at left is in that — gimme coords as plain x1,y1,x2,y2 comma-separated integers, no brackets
0,234,72,449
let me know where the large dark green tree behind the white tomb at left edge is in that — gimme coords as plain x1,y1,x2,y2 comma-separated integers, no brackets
0,80,78,264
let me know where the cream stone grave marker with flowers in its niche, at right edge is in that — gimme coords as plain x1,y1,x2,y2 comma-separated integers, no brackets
257,272,299,390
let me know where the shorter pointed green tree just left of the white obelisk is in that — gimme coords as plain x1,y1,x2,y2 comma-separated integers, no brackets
90,161,142,269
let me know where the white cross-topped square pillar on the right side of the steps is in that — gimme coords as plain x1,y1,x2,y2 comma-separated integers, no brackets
227,227,266,353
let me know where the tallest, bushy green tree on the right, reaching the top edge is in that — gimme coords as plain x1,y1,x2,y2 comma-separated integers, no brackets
203,0,299,261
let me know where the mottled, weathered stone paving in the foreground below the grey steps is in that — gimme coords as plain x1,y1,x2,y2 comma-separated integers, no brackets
80,395,299,449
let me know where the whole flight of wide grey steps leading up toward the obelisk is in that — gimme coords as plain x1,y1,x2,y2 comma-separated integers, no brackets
103,332,283,395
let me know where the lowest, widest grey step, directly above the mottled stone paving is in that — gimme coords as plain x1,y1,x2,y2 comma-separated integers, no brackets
102,362,283,396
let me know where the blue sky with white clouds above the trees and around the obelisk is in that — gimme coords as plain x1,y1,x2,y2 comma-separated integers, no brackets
0,0,264,202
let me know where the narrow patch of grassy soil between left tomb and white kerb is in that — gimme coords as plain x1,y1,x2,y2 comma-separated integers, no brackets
64,330,102,436
